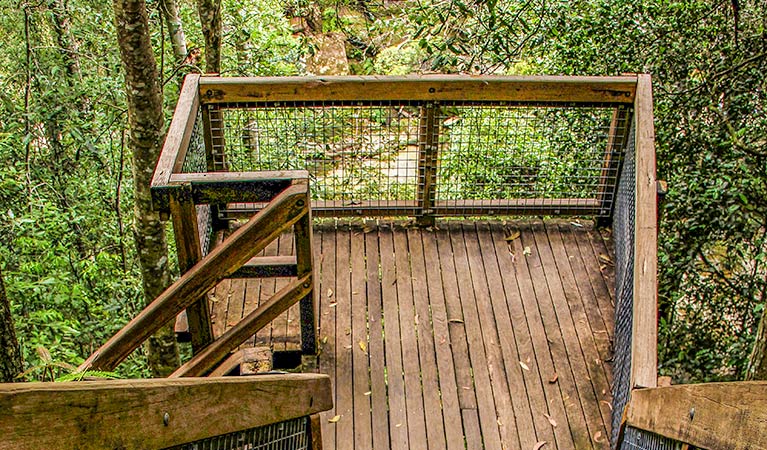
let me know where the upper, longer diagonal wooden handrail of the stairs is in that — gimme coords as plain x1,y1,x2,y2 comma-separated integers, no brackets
81,184,308,370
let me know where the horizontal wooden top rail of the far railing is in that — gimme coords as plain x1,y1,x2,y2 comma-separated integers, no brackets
200,75,637,104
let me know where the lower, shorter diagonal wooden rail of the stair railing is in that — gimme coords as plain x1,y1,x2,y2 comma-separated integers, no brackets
170,274,313,378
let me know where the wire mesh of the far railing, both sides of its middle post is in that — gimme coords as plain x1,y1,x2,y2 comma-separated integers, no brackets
196,101,626,215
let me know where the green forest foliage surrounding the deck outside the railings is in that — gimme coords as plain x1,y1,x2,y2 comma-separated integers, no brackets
0,0,767,383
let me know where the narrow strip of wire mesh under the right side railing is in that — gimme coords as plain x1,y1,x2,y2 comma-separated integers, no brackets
612,121,636,448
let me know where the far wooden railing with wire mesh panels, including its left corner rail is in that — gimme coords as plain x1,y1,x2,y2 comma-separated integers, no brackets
158,75,637,226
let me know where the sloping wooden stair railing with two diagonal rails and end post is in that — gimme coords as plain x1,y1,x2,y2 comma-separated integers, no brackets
81,173,317,376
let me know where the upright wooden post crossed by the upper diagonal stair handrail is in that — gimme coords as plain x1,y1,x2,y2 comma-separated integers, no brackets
170,184,213,353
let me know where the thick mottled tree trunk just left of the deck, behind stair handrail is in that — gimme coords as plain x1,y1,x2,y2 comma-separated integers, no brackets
114,0,179,377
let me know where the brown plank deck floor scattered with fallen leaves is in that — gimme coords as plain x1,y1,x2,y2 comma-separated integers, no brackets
212,221,614,450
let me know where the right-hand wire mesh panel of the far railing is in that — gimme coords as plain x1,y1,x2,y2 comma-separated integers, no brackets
436,104,626,208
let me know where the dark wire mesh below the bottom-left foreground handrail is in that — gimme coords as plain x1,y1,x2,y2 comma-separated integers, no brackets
165,417,311,450
